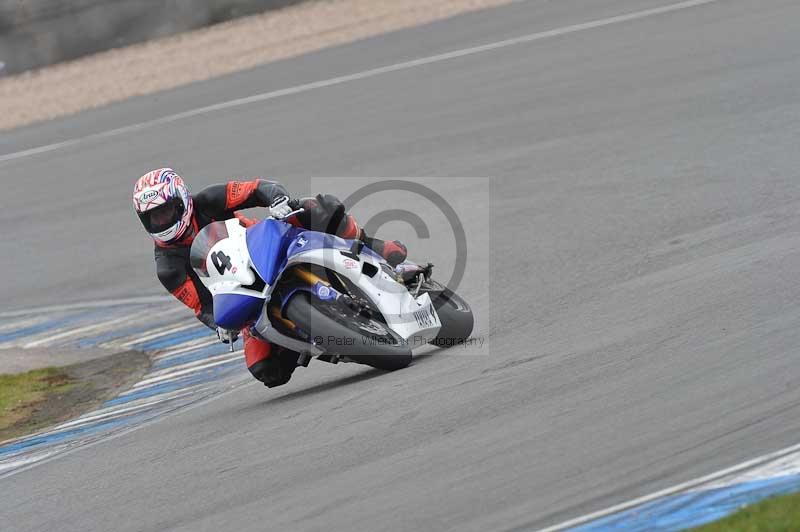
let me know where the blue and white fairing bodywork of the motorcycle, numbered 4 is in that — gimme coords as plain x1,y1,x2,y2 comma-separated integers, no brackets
190,219,441,345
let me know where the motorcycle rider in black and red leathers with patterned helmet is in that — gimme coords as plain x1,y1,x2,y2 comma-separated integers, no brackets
133,168,407,387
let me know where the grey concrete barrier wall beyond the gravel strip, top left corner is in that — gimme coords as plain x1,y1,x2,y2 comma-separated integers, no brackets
0,0,303,74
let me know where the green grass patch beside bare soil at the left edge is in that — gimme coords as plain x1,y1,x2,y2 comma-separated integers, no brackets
0,368,73,431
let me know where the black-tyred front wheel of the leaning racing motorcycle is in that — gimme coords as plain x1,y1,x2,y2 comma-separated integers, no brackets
285,292,411,371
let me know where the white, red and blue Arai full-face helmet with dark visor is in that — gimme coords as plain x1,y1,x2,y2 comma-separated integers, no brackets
133,168,192,244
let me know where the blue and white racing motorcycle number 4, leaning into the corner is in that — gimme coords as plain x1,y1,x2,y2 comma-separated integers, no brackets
190,211,474,371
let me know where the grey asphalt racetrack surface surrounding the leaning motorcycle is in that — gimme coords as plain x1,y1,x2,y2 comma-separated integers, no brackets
0,0,800,530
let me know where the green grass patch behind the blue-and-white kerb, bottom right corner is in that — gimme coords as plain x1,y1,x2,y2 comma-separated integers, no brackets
693,493,800,532
